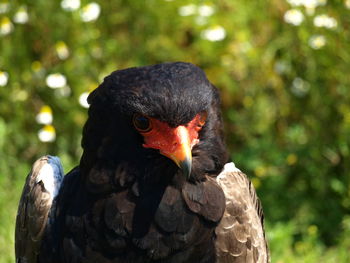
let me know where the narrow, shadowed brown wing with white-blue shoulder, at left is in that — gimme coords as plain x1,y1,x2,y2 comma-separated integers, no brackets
15,156,63,263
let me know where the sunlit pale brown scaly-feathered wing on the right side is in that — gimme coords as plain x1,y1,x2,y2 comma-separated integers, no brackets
215,163,270,263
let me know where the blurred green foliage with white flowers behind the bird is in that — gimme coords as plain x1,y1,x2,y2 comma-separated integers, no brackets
0,0,350,263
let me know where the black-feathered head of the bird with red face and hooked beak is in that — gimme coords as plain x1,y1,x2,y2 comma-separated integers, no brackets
82,62,227,184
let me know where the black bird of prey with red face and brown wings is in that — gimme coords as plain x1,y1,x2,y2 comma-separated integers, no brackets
15,62,270,263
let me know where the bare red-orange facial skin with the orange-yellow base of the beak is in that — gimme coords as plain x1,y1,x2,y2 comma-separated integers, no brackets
140,113,206,165
